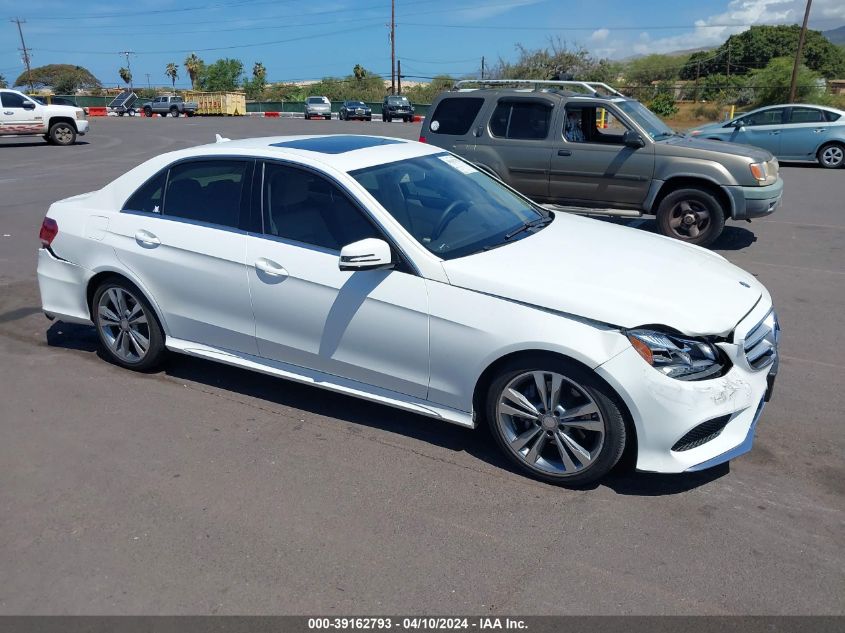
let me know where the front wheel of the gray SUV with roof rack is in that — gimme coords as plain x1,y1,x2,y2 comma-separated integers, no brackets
657,188,725,246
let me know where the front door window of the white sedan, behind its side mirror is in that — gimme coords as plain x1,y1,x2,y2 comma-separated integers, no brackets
263,163,382,251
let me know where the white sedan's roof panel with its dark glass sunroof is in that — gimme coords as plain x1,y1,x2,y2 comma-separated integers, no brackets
185,134,444,171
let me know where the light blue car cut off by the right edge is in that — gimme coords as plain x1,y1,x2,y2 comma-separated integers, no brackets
689,103,845,169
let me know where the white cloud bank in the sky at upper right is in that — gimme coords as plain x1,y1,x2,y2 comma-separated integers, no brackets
633,0,845,55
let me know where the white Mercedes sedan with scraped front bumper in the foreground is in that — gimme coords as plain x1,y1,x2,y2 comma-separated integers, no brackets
38,136,779,485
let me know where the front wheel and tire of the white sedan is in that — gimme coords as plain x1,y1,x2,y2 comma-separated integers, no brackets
485,354,626,487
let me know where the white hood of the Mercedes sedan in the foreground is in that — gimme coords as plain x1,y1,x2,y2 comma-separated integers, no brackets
443,213,766,336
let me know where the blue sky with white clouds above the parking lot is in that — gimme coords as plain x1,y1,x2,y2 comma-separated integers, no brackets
0,0,845,87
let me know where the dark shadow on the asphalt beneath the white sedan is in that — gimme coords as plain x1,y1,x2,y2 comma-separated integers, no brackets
47,322,730,497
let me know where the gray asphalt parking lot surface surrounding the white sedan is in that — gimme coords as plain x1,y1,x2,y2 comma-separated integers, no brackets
0,118,845,615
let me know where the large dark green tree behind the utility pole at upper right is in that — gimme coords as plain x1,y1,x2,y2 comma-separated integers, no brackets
681,24,845,79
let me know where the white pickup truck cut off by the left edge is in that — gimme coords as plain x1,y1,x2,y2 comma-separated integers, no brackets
0,90,88,145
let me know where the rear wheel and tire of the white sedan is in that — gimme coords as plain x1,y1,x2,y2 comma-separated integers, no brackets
91,277,166,371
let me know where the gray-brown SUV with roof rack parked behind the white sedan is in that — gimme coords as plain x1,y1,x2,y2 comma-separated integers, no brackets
420,81,783,246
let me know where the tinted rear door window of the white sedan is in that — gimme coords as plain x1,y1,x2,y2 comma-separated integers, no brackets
163,160,249,228
